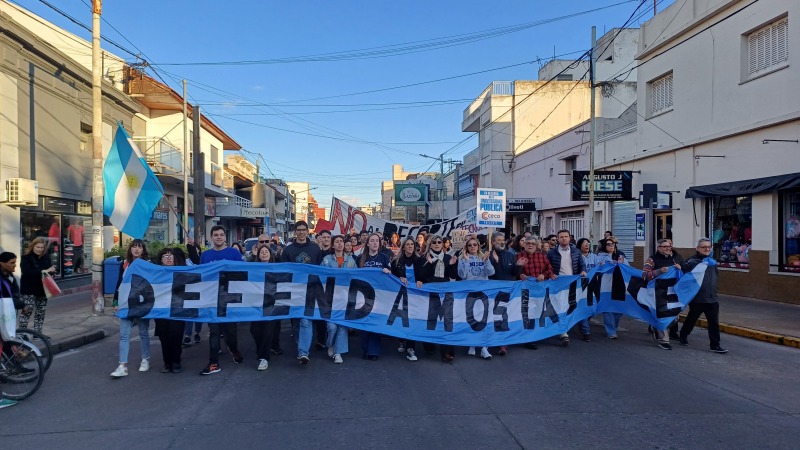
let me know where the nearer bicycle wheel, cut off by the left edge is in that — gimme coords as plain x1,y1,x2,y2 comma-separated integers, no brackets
0,340,44,400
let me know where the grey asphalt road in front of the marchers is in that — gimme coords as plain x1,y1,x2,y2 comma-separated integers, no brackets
0,319,800,449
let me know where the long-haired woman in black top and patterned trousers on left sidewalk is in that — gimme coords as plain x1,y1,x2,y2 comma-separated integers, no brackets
19,237,56,332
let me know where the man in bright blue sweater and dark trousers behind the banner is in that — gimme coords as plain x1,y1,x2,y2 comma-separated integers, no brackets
200,225,244,375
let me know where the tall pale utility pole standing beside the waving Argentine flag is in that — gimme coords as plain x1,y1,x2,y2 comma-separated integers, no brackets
92,0,105,316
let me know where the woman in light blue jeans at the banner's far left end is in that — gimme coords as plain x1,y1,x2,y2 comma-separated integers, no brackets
111,239,150,378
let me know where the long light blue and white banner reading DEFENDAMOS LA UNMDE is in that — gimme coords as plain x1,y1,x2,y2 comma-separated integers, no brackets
118,260,707,346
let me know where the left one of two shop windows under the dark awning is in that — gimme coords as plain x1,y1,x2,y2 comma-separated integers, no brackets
709,195,753,269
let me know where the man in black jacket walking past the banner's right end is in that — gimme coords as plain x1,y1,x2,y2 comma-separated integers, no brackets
679,238,728,353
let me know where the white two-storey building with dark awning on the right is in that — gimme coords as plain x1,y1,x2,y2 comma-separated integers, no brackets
596,0,800,303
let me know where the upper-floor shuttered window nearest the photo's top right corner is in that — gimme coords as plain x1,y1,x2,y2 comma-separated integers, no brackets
746,17,789,77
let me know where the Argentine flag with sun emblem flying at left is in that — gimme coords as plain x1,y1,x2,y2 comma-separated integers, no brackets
103,123,164,239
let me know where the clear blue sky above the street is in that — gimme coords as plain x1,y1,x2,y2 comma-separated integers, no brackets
13,0,673,207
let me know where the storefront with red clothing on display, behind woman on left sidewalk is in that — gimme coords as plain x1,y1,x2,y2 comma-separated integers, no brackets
20,196,92,278
